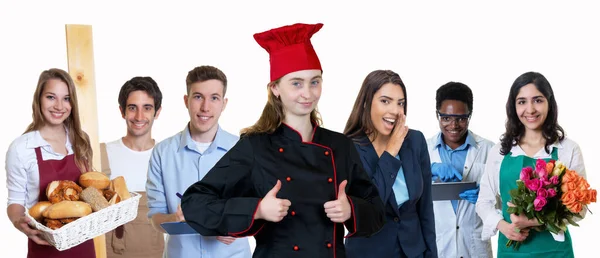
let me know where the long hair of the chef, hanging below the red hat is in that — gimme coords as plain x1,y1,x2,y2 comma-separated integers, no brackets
240,80,323,135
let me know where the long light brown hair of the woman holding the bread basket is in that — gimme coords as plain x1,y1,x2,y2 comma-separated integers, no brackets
23,68,93,172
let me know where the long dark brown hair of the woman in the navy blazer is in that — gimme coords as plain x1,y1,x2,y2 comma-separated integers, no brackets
344,70,408,141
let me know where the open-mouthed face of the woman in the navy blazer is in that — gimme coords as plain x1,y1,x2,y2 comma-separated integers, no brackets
371,83,406,137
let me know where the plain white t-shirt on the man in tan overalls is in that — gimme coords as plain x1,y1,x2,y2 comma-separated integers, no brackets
106,138,152,192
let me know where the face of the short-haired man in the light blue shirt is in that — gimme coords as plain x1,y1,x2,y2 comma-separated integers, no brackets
184,80,227,142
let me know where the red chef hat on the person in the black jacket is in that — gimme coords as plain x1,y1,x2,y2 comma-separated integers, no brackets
254,23,323,81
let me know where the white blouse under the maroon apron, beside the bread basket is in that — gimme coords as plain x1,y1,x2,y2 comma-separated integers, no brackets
6,131,73,208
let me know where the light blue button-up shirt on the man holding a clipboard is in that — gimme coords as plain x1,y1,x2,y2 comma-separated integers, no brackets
146,126,252,258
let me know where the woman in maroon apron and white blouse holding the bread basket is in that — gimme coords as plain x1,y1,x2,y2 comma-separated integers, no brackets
6,68,96,258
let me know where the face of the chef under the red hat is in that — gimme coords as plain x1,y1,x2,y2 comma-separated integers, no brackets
271,70,323,120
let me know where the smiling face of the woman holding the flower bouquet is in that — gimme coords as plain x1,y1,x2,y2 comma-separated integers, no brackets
515,83,548,131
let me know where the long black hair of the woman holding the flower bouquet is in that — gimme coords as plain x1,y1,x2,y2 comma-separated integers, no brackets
500,72,565,155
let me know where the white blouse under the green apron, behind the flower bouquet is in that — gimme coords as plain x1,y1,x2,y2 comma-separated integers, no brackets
476,137,585,240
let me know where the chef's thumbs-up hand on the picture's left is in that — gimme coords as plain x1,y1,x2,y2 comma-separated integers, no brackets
254,180,292,222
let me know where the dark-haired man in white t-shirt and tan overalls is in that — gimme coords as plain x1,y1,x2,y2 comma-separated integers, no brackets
102,77,164,258
